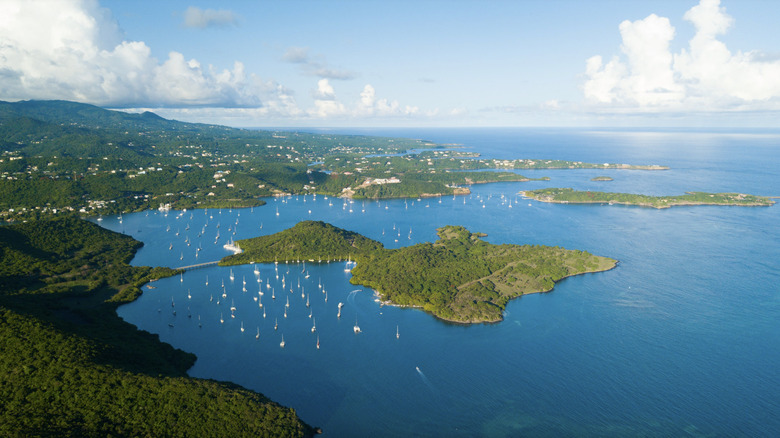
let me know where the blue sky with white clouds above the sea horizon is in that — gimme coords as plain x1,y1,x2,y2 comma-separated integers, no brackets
0,0,780,128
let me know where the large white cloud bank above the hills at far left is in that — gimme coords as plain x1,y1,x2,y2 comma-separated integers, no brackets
0,0,268,107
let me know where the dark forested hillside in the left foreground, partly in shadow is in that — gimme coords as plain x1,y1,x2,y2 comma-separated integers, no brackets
0,215,315,437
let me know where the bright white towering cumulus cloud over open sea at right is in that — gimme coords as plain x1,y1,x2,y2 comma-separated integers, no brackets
583,0,780,112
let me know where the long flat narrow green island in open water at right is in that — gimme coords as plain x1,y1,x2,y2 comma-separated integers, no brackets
520,188,775,208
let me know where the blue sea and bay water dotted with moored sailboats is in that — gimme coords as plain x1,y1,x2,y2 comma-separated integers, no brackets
111,129,780,437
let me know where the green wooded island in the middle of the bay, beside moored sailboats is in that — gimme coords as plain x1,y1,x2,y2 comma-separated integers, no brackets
220,221,617,323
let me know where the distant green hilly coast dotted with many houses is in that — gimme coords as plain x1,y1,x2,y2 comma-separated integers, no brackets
0,101,666,221
